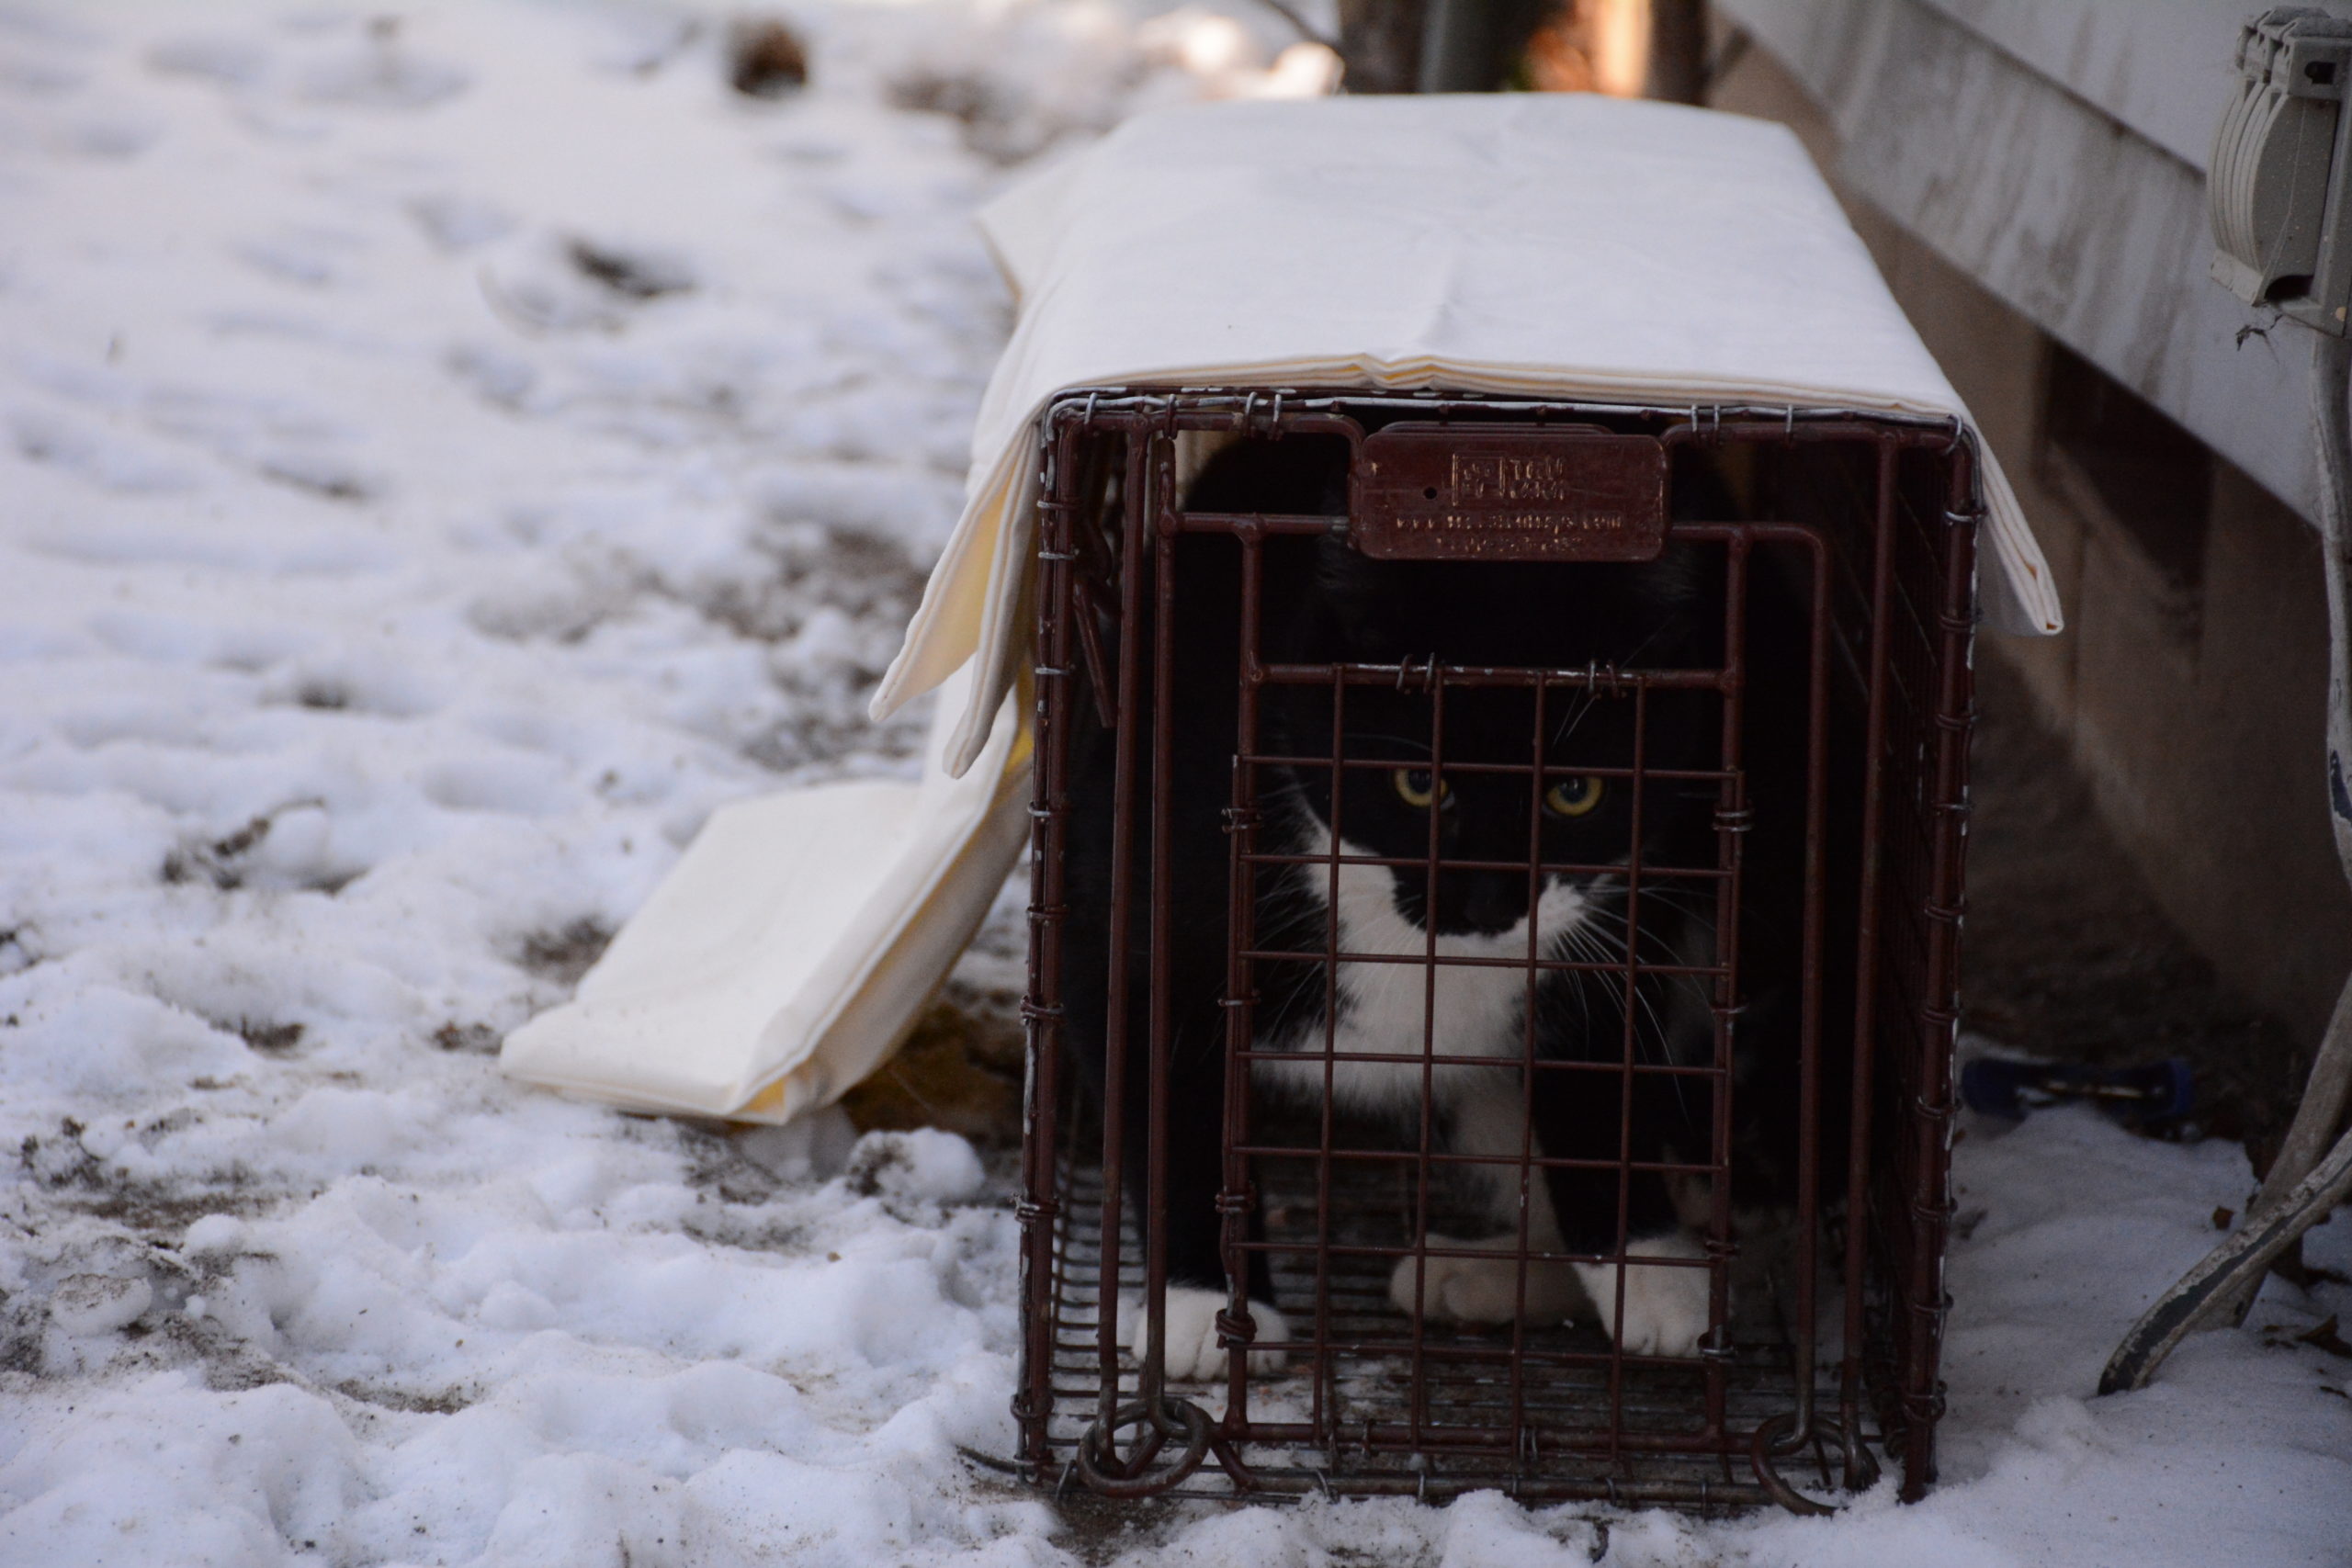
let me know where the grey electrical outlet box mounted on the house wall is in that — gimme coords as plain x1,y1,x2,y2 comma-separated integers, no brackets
2206,5,2352,336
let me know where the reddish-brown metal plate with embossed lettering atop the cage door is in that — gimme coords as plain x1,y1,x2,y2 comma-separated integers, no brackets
1348,423,1665,562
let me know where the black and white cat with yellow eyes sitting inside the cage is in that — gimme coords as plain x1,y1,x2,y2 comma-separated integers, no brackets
1063,437,1825,1378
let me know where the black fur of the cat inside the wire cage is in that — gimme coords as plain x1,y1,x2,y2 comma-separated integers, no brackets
1063,437,1841,1363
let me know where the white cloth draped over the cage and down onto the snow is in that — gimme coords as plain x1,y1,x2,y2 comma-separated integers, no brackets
503,94,2061,1122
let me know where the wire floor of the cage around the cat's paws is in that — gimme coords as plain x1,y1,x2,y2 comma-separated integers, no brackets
1040,1168,1879,1512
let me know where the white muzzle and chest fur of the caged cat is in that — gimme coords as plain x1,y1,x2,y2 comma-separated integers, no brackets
1259,823,1588,1110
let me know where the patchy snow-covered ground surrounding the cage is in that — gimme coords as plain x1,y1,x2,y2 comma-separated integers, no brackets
0,0,2352,1568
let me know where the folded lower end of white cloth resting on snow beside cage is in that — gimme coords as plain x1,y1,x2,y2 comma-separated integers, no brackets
499,672,1028,1122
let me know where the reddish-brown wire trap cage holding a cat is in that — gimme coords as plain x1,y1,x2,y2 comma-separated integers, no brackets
1013,388,1978,1512
